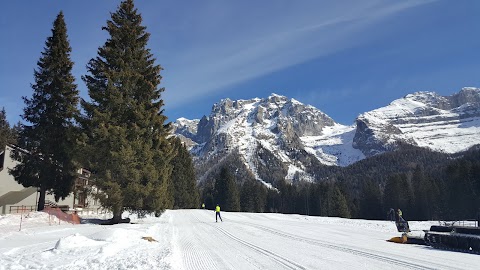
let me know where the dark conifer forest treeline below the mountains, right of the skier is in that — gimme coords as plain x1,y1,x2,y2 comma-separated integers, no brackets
202,147,480,220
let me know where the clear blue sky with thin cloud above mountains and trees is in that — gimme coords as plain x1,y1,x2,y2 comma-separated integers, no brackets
0,0,480,124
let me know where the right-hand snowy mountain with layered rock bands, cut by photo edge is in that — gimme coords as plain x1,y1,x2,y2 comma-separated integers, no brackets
353,88,480,157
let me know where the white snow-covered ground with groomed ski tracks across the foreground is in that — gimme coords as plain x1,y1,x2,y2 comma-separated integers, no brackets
0,210,480,270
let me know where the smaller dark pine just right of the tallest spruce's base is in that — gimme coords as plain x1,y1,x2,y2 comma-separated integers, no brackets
171,138,200,208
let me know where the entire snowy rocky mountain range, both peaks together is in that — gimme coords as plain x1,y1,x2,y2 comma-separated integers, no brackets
173,88,480,184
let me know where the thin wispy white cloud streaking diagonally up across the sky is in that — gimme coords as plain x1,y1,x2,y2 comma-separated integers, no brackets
154,0,432,108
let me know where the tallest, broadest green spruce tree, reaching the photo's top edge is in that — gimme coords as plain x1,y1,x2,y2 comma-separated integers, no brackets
81,0,174,222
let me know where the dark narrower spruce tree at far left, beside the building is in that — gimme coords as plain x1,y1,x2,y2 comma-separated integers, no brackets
10,12,79,210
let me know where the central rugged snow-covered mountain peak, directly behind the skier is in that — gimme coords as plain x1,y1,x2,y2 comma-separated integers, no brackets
177,94,364,183
